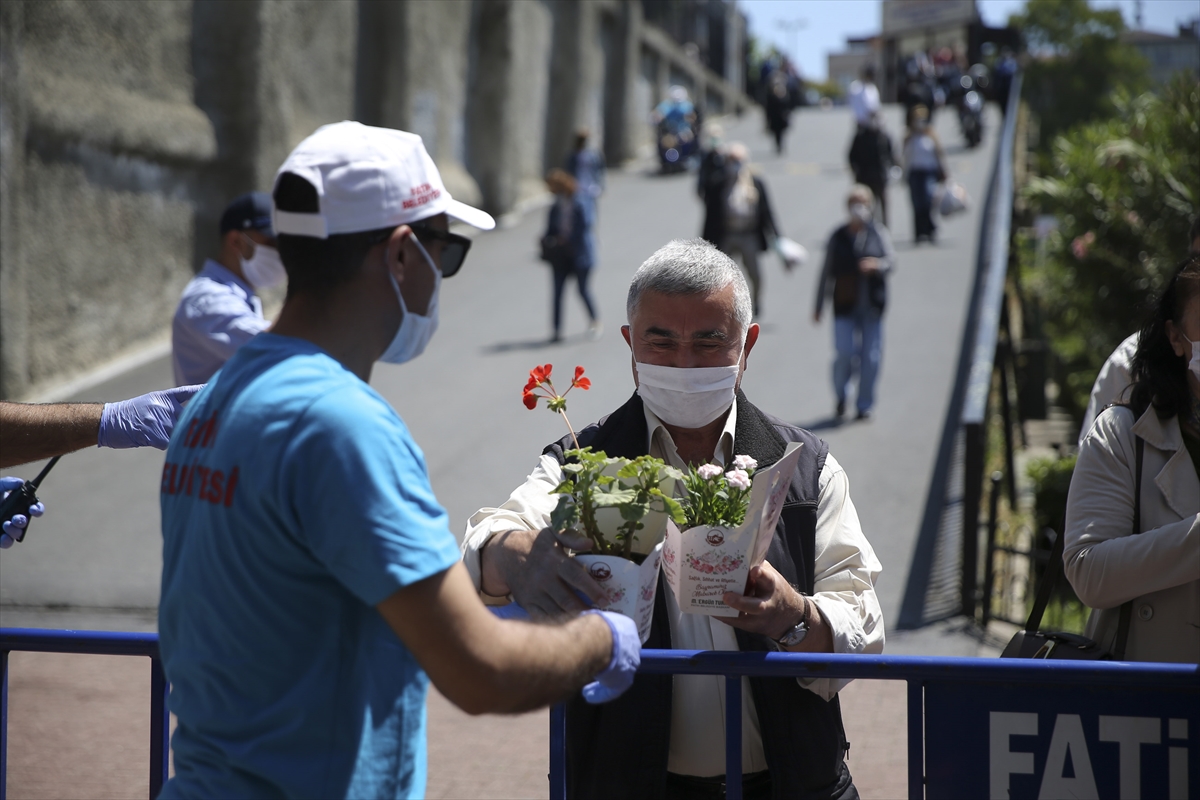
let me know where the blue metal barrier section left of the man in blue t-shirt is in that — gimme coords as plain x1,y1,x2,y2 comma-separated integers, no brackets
0,627,170,800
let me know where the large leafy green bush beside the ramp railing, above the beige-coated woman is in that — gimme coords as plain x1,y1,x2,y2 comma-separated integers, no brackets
1020,74,1200,414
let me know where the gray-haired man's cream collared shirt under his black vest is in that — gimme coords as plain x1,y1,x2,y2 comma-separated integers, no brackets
462,404,883,776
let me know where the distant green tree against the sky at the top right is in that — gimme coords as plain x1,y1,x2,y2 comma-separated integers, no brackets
1009,0,1150,150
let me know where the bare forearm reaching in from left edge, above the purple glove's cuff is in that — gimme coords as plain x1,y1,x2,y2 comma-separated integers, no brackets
0,403,104,468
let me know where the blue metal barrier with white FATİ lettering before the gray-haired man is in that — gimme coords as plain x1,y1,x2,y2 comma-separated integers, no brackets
550,650,1200,800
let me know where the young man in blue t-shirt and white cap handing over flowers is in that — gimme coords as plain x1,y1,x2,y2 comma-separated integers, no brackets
158,122,640,798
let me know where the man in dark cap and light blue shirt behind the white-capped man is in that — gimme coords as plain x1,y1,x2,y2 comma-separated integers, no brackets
170,192,280,386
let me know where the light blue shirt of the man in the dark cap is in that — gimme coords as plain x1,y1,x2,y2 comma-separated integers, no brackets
170,259,271,386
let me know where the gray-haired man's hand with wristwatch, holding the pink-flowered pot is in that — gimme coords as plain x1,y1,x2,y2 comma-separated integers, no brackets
716,561,833,652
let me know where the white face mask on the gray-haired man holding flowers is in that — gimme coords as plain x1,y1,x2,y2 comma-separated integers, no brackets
636,361,740,428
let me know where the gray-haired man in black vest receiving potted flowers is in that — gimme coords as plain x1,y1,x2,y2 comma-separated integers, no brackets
463,240,883,799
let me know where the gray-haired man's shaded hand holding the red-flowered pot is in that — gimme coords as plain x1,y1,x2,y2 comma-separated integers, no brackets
480,528,606,620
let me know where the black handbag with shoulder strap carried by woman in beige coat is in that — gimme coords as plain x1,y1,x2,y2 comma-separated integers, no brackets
1000,437,1145,661
